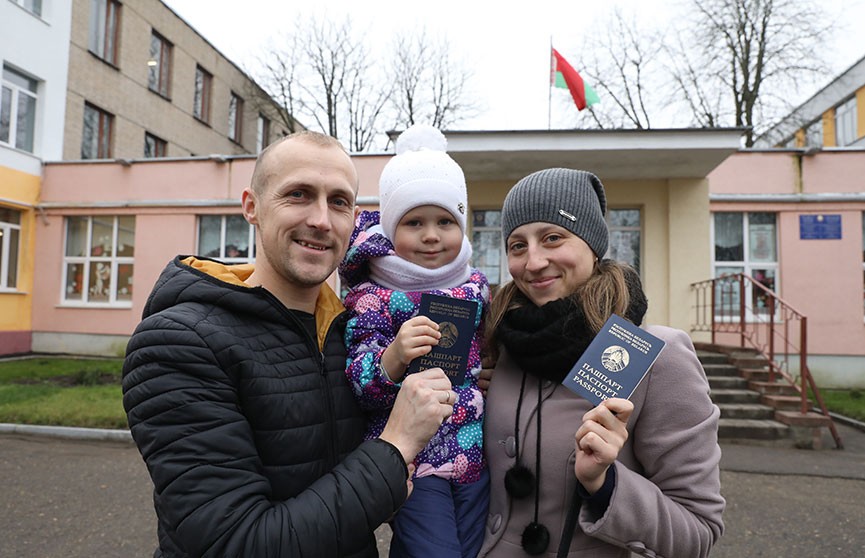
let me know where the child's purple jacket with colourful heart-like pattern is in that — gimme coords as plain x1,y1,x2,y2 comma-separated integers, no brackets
340,211,489,483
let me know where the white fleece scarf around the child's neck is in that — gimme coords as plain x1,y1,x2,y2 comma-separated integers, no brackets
367,225,472,292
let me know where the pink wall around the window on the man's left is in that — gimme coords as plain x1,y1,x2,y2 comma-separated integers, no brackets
33,156,390,342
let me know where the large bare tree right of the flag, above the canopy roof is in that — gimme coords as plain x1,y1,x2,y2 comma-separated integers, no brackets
674,0,831,146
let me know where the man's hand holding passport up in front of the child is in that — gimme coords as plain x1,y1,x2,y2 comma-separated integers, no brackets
379,368,457,463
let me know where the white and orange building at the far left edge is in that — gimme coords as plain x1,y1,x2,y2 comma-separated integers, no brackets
0,0,71,353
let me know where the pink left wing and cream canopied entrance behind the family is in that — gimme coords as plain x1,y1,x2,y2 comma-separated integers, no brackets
33,130,741,355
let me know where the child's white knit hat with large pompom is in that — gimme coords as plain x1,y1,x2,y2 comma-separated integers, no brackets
379,124,468,240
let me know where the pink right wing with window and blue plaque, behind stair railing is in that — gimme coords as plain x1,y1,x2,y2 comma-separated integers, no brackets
709,149,865,388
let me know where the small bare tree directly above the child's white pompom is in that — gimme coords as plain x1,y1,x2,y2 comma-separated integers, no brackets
390,29,480,129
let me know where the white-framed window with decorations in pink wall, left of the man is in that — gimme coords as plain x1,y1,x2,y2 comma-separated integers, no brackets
62,215,135,306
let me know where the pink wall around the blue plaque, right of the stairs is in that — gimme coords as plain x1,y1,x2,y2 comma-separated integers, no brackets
709,150,865,356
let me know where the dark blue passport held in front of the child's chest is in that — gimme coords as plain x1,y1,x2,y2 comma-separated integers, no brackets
407,293,478,386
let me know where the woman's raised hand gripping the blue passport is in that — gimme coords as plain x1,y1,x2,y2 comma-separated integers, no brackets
574,398,634,494
